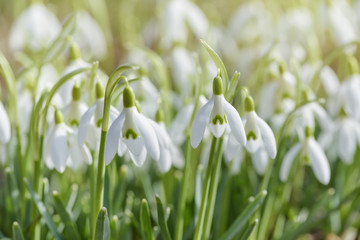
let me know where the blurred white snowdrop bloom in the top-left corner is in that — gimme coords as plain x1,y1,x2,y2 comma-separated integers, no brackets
9,3,61,51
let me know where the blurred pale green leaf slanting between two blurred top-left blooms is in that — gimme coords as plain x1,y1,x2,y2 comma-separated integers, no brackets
43,14,76,63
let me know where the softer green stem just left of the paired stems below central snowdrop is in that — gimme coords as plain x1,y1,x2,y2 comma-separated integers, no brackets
175,137,192,240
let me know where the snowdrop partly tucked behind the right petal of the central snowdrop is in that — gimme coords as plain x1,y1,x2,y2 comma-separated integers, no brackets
243,96,276,159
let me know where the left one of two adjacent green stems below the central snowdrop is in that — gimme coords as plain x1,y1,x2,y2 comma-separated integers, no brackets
194,137,217,240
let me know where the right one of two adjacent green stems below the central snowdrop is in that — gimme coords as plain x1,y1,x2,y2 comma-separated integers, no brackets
204,138,223,239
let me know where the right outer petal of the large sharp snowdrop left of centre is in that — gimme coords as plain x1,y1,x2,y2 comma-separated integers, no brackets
134,111,160,160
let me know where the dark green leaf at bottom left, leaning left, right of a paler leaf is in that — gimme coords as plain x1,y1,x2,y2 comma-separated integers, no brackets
52,191,81,239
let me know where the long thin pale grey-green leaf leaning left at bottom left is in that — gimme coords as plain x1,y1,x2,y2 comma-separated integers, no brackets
24,179,64,240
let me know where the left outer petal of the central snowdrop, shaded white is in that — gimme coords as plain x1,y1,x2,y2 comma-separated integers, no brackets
191,98,214,148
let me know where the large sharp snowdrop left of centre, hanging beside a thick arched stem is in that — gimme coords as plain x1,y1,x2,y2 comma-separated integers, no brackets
105,86,160,168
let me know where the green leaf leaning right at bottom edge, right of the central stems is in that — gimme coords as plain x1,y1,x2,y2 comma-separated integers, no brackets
221,190,267,240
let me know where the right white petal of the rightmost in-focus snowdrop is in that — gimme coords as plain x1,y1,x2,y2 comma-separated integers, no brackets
307,138,330,185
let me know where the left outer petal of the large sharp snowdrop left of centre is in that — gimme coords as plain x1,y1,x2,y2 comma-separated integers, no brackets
104,112,125,165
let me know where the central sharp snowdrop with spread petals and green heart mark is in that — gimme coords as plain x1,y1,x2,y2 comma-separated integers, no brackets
191,75,246,148
